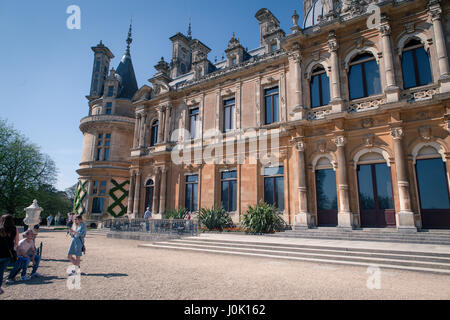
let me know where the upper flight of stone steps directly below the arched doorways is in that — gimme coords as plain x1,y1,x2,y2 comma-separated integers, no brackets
269,228,450,245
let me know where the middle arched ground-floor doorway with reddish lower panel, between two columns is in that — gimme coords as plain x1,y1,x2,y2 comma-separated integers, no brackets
356,152,396,228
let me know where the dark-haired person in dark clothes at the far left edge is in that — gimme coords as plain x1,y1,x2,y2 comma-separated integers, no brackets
0,214,19,295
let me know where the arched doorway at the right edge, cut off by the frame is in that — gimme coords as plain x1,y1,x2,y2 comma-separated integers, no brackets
415,146,450,229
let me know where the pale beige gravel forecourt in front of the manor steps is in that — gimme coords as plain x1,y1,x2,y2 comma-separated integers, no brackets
0,231,450,300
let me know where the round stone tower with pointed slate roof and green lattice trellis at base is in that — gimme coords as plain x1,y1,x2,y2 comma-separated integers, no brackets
74,25,138,222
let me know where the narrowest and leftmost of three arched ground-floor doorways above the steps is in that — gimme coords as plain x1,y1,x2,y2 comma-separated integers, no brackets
315,157,338,227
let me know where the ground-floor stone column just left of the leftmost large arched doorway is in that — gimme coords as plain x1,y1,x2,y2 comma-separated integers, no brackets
295,140,314,230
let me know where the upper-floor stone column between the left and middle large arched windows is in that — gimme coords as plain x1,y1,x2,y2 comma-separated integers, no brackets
328,31,344,112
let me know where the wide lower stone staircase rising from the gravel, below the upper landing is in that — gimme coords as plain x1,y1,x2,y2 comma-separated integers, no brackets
139,238,450,275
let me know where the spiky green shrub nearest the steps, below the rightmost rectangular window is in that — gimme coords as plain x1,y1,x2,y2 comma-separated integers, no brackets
241,202,286,233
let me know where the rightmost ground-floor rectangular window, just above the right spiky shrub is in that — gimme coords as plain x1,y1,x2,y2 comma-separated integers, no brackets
264,166,284,211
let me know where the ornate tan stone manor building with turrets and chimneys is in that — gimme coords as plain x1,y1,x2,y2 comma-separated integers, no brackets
75,0,450,231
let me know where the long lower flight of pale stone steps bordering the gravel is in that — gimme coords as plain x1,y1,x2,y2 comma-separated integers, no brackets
139,240,450,275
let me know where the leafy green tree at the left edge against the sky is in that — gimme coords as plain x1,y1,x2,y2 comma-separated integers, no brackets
0,119,57,217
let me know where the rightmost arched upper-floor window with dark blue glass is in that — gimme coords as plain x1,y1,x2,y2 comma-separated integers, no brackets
402,39,433,89
